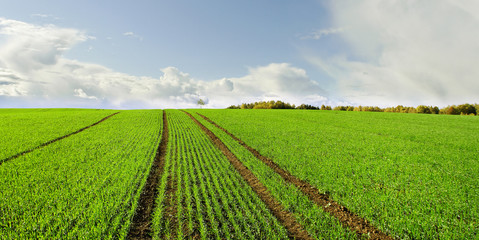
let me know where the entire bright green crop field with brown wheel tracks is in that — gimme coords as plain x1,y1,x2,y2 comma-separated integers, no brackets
0,109,479,239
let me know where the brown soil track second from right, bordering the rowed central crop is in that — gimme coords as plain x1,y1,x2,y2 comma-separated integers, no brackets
183,111,312,239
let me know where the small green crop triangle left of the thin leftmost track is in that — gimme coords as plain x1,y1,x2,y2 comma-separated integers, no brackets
0,109,115,160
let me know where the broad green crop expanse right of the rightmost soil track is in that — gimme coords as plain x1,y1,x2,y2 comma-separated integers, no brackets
198,110,479,239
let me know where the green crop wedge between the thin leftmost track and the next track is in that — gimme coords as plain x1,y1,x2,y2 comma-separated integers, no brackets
0,111,162,239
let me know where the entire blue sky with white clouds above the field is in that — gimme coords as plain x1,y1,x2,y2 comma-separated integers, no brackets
0,0,479,109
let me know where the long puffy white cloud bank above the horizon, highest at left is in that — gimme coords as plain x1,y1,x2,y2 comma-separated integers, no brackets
0,18,327,108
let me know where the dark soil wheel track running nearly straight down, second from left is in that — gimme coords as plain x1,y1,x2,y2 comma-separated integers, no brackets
127,110,171,239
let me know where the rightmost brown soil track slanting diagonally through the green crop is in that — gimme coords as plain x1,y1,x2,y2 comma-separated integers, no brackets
196,113,393,239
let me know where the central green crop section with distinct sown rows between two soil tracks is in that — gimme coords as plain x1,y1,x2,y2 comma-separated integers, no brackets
154,110,287,239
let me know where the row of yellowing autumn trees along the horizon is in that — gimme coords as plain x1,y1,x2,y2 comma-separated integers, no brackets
228,101,479,115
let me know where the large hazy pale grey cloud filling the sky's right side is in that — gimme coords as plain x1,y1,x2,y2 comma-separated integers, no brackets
307,0,479,105
